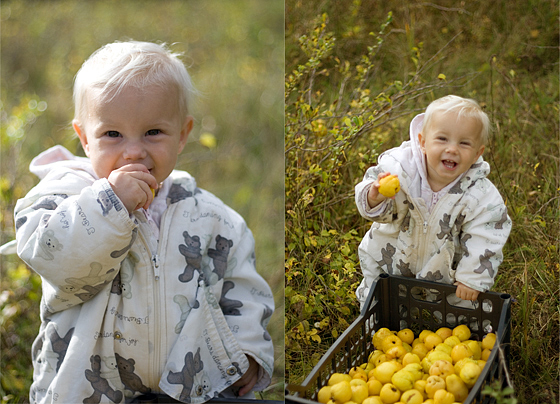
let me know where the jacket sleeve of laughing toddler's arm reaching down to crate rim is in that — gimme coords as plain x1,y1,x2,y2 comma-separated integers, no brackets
455,185,512,292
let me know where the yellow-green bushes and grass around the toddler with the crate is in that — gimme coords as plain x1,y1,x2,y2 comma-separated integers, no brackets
285,0,560,403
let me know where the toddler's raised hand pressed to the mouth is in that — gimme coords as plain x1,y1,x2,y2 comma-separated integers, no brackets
107,164,158,213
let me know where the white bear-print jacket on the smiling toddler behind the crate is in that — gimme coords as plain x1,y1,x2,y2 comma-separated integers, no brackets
355,114,512,303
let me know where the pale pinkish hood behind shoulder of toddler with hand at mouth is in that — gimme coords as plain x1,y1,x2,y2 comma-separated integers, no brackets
29,145,97,179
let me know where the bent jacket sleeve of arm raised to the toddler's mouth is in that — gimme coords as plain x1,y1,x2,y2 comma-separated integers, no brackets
15,170,135,313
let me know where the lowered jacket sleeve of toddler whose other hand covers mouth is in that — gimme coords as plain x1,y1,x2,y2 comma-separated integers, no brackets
220,208,275,391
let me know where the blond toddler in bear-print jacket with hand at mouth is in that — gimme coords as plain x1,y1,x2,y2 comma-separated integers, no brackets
15,41,274,403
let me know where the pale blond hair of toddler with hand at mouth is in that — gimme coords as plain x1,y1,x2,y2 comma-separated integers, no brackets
74,41,196,121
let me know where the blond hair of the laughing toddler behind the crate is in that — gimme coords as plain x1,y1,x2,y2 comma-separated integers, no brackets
422,95,490,144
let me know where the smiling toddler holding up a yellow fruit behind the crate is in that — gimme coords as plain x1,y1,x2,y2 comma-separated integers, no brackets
355,95,511,303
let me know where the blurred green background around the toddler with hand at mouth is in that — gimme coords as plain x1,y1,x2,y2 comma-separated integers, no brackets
0,0,284,402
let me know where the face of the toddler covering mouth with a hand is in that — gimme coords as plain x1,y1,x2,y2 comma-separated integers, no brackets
73,86,193,183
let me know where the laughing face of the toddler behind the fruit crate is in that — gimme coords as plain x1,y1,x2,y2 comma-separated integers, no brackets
418,112,484,192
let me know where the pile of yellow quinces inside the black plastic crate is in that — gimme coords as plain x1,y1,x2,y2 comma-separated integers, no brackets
318,325,496,404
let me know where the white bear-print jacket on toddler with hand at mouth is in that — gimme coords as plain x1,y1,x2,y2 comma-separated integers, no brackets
15,146,274,403
